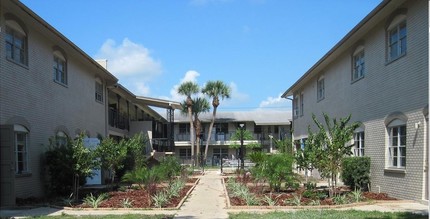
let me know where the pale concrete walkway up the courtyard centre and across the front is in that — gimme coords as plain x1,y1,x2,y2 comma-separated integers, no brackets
0,170,429,219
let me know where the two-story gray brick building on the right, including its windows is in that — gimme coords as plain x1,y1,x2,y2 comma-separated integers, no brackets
283,0,429,201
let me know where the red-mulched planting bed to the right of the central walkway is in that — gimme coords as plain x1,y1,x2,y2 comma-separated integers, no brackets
223,177,396,208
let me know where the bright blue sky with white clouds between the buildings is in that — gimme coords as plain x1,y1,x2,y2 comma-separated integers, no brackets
21,0,381,111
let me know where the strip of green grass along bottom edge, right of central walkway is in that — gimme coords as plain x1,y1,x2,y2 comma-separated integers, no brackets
229,210,428,219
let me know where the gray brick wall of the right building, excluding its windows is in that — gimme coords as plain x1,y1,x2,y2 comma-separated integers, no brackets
294,1,429,200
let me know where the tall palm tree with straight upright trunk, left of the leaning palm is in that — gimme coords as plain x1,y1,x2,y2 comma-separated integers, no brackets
178,81,199,165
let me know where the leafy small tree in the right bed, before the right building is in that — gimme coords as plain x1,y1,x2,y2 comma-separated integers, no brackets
309,113,359,193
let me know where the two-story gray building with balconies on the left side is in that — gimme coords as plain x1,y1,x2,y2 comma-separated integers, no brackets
0,0,180,207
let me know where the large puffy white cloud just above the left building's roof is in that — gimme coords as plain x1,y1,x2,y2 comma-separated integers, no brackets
96,38,162,80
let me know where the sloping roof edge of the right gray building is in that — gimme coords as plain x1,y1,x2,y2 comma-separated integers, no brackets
281,0,392,98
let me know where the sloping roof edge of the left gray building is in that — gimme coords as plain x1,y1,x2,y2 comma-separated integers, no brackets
11,0,118,84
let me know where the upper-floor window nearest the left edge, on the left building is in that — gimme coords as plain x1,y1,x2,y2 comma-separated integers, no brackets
6,20,27,65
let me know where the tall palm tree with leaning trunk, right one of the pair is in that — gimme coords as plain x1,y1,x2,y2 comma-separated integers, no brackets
202,81,231,160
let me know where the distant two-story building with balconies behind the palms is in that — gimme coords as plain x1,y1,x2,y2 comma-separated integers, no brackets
174,111,291,166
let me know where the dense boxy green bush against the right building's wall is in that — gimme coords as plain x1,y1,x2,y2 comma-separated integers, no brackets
341,157,370,191
